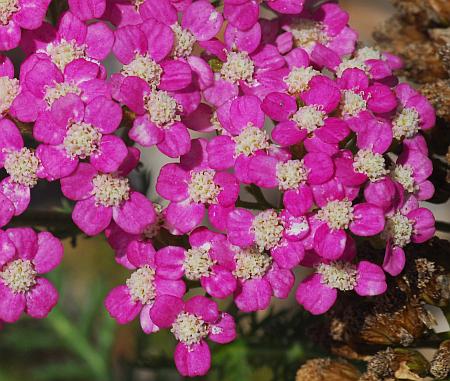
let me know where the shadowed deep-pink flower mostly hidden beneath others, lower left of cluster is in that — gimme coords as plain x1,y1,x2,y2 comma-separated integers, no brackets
105,204,165,269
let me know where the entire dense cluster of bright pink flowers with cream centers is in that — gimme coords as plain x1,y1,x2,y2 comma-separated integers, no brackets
0,0,435,376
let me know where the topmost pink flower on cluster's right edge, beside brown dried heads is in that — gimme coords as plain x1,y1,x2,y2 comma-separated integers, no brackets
392,83,436,140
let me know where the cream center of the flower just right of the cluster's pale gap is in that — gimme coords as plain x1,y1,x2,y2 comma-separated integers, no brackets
188,169,222,204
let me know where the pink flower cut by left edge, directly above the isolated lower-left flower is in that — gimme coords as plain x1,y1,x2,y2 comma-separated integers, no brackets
0,119,43,226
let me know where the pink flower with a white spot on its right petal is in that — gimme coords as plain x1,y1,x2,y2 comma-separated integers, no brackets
227,208,304,269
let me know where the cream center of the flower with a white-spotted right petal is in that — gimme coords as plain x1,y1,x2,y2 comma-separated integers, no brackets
251,209,283,251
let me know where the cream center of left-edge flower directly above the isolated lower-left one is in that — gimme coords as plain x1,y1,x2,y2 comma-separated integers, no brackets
4,147,40,187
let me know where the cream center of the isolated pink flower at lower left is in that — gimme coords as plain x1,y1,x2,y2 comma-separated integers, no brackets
0,259,37,294
